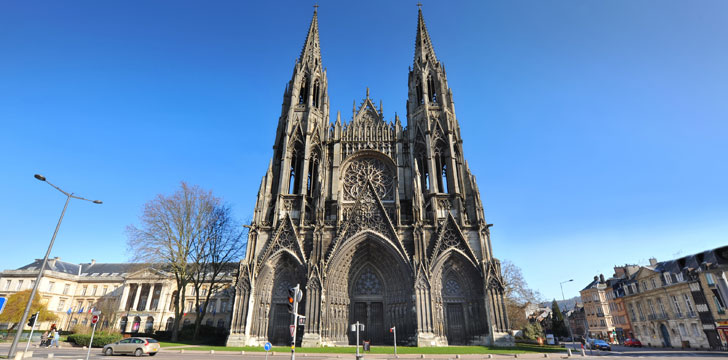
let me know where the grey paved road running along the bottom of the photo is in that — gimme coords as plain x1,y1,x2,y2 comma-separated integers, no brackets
0,344,728,360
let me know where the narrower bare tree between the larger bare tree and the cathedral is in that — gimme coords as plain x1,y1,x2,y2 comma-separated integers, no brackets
190,205,247,340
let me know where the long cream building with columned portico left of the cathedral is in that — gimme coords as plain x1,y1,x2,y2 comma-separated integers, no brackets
0,257,236,334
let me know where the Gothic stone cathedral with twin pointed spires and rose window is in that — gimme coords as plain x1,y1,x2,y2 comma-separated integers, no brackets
227,10,512,346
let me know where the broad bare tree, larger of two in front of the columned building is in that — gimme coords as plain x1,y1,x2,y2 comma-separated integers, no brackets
127,182,220,341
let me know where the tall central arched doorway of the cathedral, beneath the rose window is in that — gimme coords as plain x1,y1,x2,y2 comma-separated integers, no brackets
324,231,416,346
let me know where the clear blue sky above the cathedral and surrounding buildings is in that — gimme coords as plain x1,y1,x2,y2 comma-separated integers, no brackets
0,0,728,298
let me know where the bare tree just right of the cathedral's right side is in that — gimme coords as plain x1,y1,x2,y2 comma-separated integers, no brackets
501,260,542,329
